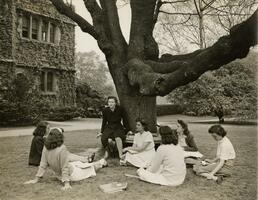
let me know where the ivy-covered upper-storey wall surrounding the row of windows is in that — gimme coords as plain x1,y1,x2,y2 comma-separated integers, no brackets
14,0,75,70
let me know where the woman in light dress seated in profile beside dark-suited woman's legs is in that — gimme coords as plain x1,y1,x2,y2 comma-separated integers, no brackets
120,119,155,167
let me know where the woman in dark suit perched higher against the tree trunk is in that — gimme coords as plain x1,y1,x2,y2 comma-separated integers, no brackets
98,96,128,158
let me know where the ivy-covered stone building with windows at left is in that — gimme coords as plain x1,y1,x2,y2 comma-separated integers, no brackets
0,0,76,106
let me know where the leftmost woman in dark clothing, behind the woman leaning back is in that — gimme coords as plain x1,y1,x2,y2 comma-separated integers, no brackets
29,121,50,166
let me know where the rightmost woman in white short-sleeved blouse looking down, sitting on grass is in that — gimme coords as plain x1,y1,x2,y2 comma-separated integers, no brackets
193,125,236,183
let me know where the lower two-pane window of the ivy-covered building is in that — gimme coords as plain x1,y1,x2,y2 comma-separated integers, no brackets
40,71,54,92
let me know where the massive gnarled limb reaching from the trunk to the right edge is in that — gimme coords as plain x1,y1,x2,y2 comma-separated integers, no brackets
127,11,258,96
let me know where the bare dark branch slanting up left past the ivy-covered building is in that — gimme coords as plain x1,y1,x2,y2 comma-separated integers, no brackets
50,0,99,40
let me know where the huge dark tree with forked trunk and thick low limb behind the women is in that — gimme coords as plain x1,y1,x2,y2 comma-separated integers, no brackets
50,0,257,131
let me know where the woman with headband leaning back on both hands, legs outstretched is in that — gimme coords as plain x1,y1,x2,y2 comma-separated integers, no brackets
24,128,107,190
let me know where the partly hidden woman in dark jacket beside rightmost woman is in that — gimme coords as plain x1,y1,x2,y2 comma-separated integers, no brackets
177,120,203,164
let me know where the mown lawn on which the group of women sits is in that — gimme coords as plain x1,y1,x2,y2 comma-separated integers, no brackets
0,124,257,200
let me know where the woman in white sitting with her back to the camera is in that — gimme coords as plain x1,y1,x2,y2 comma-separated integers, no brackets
137,126,186,186
